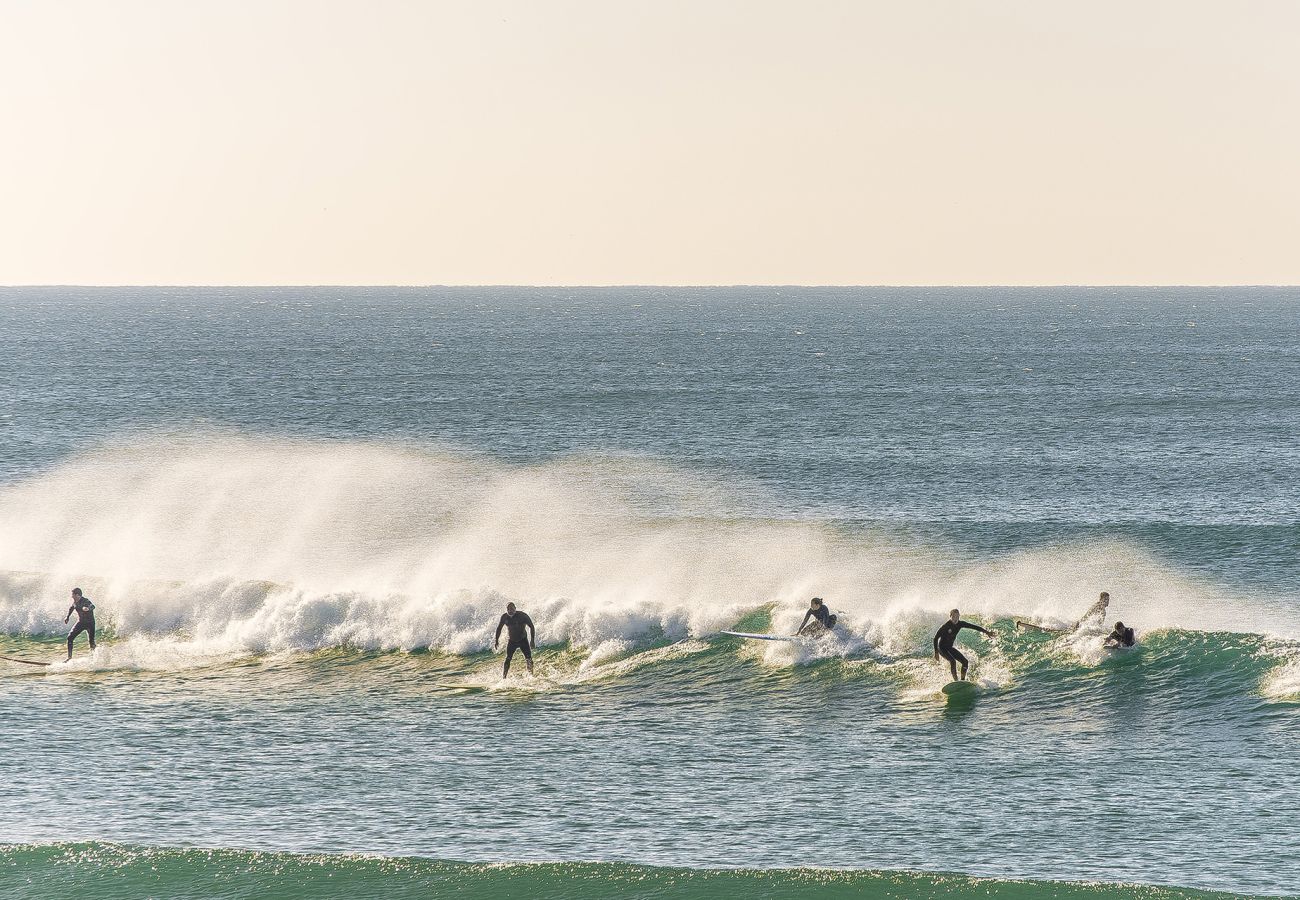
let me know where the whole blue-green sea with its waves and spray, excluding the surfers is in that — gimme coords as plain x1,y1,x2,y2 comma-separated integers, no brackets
0,287,1300,900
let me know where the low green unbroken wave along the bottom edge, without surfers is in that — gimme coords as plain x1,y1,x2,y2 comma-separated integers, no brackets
0,844,1242,900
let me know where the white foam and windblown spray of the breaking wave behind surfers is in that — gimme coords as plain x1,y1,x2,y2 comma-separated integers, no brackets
0,433,1297,655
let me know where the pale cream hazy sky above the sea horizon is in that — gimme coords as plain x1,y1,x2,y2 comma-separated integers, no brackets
0,0,1300,285
